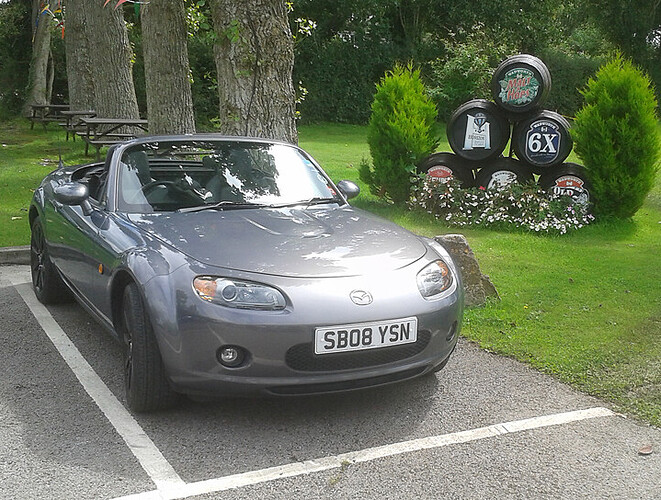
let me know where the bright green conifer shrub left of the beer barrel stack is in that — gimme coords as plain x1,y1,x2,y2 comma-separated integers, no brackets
360,64,438,203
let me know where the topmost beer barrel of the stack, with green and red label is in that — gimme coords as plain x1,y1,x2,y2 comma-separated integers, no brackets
491,54,551,114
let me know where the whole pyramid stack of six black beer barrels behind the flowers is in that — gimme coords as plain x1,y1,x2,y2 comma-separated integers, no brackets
419,54,590,204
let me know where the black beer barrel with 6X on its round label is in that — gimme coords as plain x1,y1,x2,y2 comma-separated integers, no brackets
512,110,573,174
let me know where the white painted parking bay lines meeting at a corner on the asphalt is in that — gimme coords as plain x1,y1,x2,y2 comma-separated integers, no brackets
9,276,616,500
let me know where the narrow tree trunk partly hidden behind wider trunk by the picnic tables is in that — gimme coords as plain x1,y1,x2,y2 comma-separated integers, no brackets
64,0,94,111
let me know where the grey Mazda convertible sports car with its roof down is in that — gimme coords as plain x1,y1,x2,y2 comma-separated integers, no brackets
29,134,463,411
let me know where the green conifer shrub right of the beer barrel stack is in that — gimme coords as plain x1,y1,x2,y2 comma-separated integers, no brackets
572,55,661,218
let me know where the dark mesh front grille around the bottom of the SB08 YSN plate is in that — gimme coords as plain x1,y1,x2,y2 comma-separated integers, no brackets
285,330,431,372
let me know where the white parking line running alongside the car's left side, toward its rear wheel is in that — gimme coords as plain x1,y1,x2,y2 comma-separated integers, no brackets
14,284,186,490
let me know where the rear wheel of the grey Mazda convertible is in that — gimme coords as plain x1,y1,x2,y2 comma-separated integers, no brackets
30,217,72,304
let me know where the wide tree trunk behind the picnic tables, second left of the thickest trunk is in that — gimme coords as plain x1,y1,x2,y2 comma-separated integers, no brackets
82,0,140,118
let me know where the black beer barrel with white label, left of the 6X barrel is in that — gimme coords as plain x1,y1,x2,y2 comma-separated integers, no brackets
447,99,510,161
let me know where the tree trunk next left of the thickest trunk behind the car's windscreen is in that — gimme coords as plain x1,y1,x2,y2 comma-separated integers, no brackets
140,0,195,134
